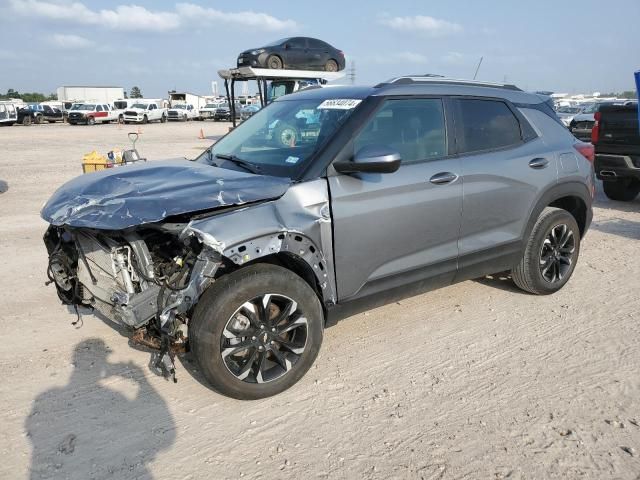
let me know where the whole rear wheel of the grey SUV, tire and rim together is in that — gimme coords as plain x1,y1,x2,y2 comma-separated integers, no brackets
511,207,580,295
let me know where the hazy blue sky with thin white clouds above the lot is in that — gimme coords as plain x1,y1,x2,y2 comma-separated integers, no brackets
0,0,640,97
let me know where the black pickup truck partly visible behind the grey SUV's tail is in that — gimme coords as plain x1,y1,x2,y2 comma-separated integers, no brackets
591,103,640,202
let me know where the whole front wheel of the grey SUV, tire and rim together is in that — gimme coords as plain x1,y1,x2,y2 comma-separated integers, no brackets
189,264,324,400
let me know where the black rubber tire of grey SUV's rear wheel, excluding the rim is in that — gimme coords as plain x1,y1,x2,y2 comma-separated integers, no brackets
526,209,581,294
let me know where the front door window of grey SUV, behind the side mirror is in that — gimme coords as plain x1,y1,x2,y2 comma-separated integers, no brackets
354,98,447,163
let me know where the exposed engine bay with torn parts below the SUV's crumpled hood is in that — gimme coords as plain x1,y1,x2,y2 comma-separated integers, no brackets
44,223,223,381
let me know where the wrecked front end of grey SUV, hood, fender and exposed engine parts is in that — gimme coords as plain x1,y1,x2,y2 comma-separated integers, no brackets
42,161,336,380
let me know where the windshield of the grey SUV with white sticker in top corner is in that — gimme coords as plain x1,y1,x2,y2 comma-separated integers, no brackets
196,99,360,178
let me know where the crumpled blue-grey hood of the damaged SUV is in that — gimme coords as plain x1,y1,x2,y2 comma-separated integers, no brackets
41,160,290,230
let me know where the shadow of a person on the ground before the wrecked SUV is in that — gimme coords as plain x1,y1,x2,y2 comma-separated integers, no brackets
25,338,176,480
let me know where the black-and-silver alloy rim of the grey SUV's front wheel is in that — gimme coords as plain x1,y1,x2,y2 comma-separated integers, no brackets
220,293,308,383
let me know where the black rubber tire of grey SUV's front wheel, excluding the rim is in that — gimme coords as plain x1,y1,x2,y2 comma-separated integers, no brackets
189,264,324,400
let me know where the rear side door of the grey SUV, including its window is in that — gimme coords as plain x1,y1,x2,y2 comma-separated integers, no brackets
452,98,558,280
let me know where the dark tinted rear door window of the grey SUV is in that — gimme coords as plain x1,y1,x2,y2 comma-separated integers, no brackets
457,99,522,153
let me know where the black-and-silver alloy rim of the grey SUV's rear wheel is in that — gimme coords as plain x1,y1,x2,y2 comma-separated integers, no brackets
540,223,576,283
